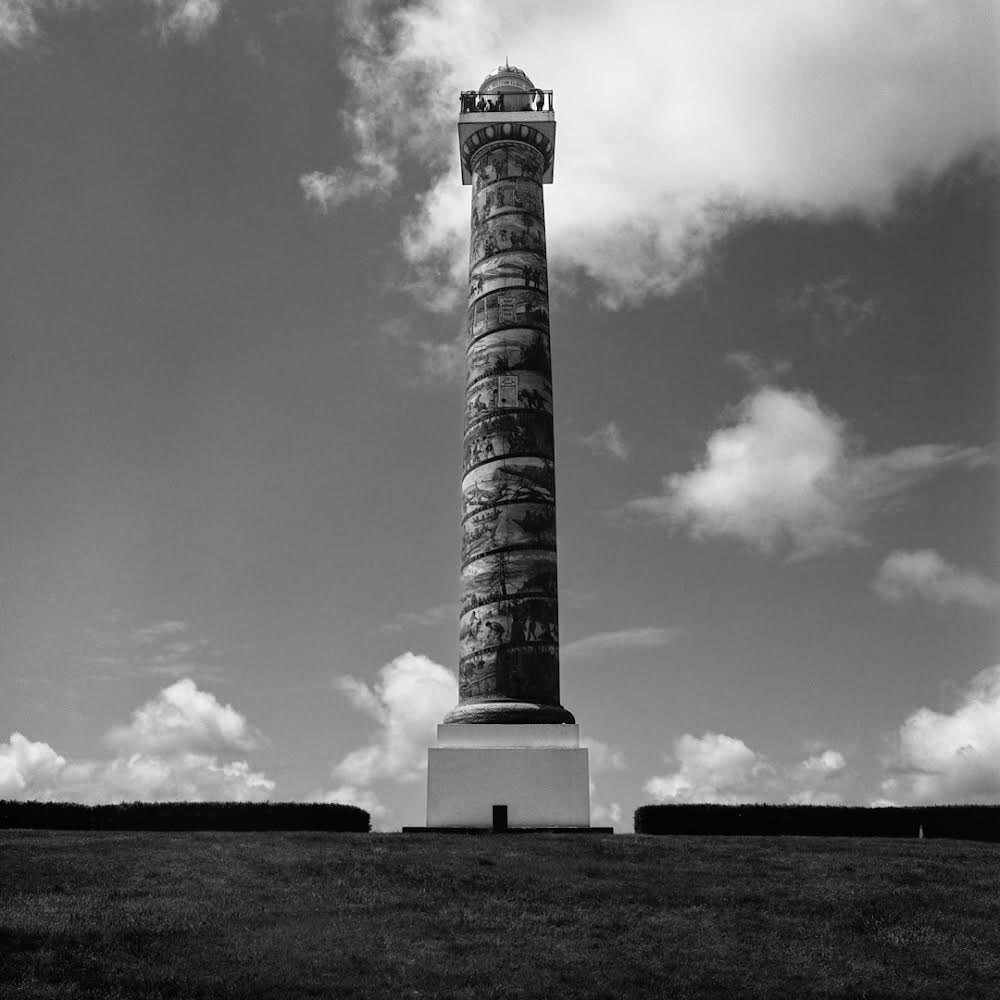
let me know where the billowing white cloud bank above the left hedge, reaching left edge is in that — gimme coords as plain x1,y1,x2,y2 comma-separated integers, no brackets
0,680,275,802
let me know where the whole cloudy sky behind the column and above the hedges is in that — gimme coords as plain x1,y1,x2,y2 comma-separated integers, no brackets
0,0,1000,830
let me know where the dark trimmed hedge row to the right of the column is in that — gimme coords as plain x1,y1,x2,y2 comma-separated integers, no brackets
635,804,1000,842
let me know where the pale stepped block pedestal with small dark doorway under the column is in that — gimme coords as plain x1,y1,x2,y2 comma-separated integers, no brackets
427,724,590,827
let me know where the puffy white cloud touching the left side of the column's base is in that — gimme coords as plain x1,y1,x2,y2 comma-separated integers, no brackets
333,653,458,788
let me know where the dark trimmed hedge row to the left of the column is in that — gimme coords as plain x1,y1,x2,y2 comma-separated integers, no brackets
0,799,371,833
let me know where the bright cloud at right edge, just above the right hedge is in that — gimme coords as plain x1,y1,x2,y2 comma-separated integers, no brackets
882,665,1000,804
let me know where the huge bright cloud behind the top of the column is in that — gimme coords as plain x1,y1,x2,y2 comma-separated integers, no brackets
310,0,1000,306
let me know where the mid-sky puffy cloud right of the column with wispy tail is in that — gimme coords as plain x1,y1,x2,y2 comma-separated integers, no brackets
626,386,990,559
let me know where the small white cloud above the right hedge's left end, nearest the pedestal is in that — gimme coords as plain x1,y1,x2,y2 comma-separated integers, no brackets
643,732,774,802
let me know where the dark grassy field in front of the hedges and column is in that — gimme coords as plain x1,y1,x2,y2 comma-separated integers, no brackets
0,831,1000,1000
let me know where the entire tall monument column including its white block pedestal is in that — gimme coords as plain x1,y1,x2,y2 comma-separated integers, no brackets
414,65,592,832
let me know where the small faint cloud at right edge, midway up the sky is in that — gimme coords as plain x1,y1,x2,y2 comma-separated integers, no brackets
873,549,1000,611
